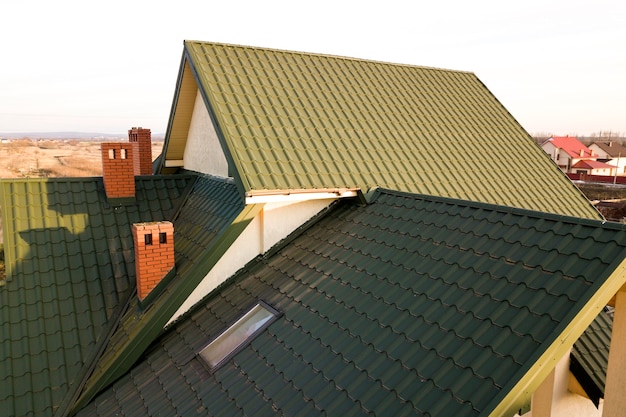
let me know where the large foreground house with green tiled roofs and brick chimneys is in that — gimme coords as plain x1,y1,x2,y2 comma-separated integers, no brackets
0,42,626,417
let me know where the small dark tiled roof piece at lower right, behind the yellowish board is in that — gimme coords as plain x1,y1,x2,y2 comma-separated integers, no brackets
570,311,613,406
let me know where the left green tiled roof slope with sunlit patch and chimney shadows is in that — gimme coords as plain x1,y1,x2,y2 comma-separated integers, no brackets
0,176,191,416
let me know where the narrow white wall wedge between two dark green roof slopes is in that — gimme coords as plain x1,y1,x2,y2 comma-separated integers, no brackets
166,200,333,327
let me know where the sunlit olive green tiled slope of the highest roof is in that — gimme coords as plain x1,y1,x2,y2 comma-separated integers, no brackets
178,41,600,219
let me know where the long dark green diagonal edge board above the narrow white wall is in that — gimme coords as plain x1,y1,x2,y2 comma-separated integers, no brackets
71,204,263,414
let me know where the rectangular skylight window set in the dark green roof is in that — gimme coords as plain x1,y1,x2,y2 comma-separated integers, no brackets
199,301,279,371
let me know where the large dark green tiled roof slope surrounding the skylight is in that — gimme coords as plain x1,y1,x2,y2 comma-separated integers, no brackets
79,190,626,416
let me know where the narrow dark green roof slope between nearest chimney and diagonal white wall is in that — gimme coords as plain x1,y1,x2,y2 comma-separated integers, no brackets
73,175,251,410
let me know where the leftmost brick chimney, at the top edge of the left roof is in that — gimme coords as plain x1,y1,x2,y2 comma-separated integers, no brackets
100,142,135,199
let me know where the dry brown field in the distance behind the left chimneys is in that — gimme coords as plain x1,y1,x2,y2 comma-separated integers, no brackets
0,139,163,178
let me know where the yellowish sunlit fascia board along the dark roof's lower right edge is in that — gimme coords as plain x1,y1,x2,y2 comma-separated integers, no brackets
485,258,626,417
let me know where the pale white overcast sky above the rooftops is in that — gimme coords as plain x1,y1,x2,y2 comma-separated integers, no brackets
0,0,626,136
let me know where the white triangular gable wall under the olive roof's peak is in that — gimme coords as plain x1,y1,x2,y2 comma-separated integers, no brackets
183,90,228,177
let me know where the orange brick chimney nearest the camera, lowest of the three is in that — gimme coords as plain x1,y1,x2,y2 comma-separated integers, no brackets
133,221,174,301
